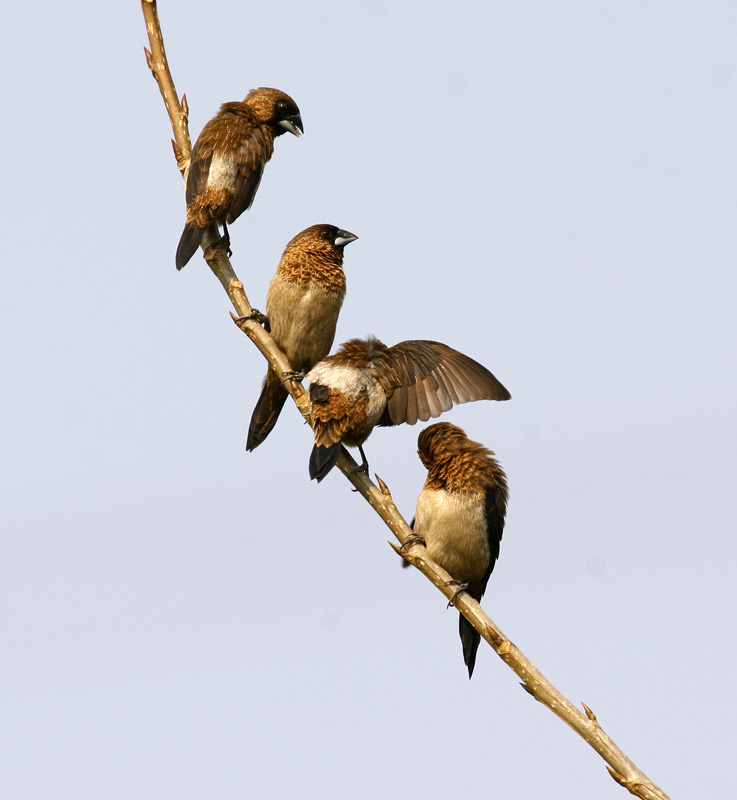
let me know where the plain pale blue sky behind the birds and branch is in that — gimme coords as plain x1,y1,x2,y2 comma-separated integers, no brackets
0,0,737,800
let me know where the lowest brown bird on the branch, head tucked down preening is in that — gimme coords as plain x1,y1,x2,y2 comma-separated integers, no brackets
403,422,509,679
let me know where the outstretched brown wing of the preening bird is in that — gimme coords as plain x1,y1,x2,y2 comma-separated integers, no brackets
379,340,511,425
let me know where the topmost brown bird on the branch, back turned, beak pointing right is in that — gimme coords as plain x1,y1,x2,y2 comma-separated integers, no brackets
176,87,304,269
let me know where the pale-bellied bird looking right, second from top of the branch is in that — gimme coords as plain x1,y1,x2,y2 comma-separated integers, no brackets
246,225,358,450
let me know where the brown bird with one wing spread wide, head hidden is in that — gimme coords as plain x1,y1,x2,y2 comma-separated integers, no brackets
307,336,511,483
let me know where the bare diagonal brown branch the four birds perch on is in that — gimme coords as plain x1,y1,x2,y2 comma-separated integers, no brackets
141,0,670,800
